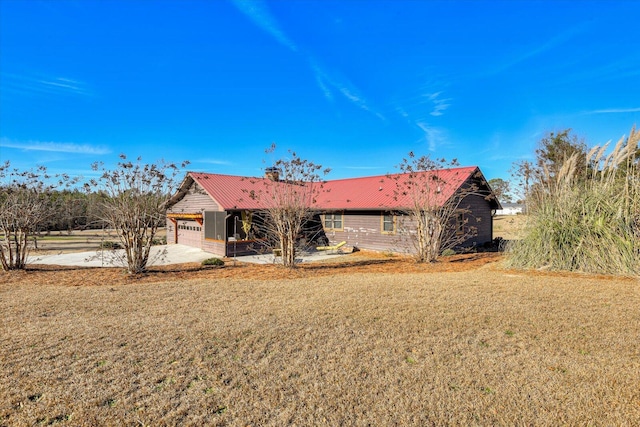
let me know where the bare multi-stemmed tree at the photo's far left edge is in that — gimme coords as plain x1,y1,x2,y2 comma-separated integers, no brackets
0,162,71,271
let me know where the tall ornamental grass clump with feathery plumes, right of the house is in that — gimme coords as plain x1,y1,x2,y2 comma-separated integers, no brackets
507,127,640,276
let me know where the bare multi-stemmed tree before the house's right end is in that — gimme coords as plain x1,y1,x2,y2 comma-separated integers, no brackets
389,152,478,262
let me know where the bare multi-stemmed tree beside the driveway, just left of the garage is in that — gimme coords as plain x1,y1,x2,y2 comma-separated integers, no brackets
85,154,187,274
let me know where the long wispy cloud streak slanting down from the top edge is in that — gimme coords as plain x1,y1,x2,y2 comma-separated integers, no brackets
231,0,386,120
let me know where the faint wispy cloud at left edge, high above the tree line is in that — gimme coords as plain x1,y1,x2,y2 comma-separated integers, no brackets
2,73,92,96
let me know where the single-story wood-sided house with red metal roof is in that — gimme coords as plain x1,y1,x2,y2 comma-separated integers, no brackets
167,167,501,256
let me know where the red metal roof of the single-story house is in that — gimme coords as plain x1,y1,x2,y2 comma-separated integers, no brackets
182,166,478,210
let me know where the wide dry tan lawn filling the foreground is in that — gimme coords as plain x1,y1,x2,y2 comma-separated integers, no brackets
0,254,640,426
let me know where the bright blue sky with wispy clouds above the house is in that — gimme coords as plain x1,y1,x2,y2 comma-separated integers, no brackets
0,0,640,179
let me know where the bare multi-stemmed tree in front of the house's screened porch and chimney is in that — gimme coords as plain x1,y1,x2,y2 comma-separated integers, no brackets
246,146,330,268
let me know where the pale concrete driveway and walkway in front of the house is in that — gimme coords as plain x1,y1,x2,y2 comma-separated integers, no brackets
27,244,339,267
